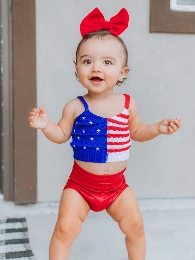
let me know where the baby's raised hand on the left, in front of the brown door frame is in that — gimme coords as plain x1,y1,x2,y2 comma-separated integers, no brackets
28,108,49,130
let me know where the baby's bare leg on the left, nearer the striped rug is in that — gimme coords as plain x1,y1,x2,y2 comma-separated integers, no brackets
49,189,90,260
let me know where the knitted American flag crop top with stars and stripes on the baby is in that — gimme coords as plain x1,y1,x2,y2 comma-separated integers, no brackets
70,94,131,163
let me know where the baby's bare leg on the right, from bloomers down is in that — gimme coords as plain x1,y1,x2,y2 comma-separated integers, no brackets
107,188,146,260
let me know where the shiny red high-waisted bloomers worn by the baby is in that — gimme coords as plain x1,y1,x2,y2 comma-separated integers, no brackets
64,162,129,212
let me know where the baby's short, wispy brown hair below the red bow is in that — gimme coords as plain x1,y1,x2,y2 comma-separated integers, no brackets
75,30,128,85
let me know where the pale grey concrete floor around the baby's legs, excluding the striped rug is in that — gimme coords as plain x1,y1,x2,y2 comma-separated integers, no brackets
0,199,195,260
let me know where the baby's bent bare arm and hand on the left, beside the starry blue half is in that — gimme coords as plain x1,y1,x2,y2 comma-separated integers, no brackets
28,101,74,144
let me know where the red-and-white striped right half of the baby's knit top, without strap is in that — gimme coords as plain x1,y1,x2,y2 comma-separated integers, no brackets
107,108,131,162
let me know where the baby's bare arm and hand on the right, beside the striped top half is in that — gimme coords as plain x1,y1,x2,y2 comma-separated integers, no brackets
130,98,181,142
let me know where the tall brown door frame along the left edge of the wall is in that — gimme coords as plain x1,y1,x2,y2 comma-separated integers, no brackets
1,0,37,204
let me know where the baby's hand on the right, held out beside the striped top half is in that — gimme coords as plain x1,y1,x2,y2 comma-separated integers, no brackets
158,118,181,135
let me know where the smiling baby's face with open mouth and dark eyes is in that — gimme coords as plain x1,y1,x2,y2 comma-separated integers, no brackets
76,37,128,93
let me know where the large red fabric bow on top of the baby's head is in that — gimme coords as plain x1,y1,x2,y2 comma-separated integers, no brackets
80,7,129,37
